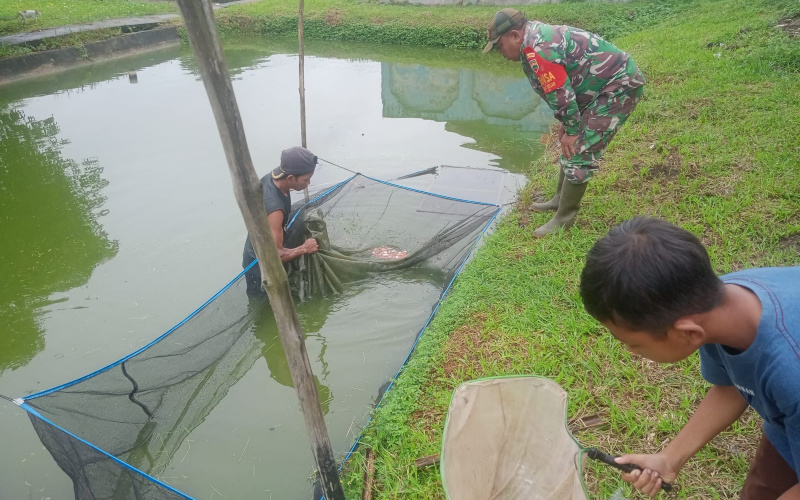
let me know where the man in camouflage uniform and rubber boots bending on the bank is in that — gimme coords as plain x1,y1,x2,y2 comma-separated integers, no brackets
483,8,644,237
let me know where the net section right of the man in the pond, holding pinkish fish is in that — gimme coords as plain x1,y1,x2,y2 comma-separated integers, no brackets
285,176,497,299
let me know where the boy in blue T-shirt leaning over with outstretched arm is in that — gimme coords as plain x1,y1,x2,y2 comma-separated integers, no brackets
580,217,800,500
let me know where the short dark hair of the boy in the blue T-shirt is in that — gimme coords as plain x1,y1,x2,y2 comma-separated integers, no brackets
580,216,724,336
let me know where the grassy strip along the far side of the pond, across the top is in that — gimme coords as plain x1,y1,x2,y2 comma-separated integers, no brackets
0,0,692,58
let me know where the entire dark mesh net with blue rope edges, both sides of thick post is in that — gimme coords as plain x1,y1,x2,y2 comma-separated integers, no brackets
22,176,499,500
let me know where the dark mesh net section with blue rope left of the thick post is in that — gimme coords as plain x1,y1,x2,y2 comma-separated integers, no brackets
20,278,259,500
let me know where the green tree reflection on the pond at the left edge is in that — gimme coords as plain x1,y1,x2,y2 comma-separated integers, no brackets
0,107,117,373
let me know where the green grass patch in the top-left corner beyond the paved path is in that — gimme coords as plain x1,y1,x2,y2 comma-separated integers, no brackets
0,0,178,35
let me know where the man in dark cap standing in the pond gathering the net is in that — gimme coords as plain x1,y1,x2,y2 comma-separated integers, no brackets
242,147,319,293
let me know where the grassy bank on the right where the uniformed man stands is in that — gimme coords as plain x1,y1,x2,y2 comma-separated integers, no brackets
328,0,800,499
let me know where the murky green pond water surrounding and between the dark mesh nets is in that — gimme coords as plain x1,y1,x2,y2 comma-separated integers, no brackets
0,39,552,499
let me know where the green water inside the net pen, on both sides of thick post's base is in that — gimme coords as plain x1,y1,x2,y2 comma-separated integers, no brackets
144,270,444,498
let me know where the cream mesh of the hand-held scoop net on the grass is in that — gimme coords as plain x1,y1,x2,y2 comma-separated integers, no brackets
441,377,588,500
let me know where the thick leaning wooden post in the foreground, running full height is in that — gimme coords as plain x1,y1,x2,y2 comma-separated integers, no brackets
178,0,344,500
